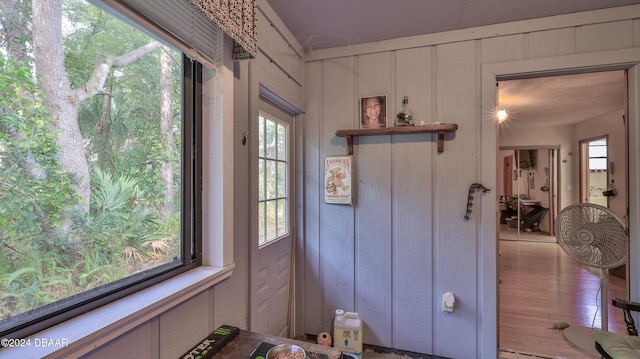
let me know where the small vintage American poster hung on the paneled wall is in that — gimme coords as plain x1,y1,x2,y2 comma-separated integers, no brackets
324,156,352,204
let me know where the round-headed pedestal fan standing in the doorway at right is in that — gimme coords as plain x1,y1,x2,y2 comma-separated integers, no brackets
555,203,627,352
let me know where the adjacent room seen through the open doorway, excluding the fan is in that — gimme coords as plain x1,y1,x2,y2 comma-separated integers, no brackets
496,70,629,358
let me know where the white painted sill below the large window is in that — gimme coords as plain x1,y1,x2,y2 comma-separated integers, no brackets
0,264,234,358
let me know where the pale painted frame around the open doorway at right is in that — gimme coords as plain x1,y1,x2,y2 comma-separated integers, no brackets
476,48,640,358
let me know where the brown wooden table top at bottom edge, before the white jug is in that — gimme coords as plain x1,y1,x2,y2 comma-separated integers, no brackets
214,330,342,359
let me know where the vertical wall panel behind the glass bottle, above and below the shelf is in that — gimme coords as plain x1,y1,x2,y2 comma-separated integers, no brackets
392,47,434,353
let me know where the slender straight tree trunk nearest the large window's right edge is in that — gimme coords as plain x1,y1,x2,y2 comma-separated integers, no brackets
160,47,174,218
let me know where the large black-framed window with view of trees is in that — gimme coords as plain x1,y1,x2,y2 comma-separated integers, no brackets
0,0,201,338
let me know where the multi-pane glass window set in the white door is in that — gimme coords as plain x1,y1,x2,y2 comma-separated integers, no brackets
258,113,289,245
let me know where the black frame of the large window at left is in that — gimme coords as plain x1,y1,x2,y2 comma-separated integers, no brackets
0,5,203,348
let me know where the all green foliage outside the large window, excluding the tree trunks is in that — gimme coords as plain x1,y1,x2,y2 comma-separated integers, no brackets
0,0,181,328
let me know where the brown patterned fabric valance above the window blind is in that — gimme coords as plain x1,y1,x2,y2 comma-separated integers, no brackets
189,0,258,61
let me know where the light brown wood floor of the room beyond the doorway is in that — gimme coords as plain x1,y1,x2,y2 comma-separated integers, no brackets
498,226,627,359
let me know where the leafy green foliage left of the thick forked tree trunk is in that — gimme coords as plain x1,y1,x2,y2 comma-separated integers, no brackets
0,56,77,257
